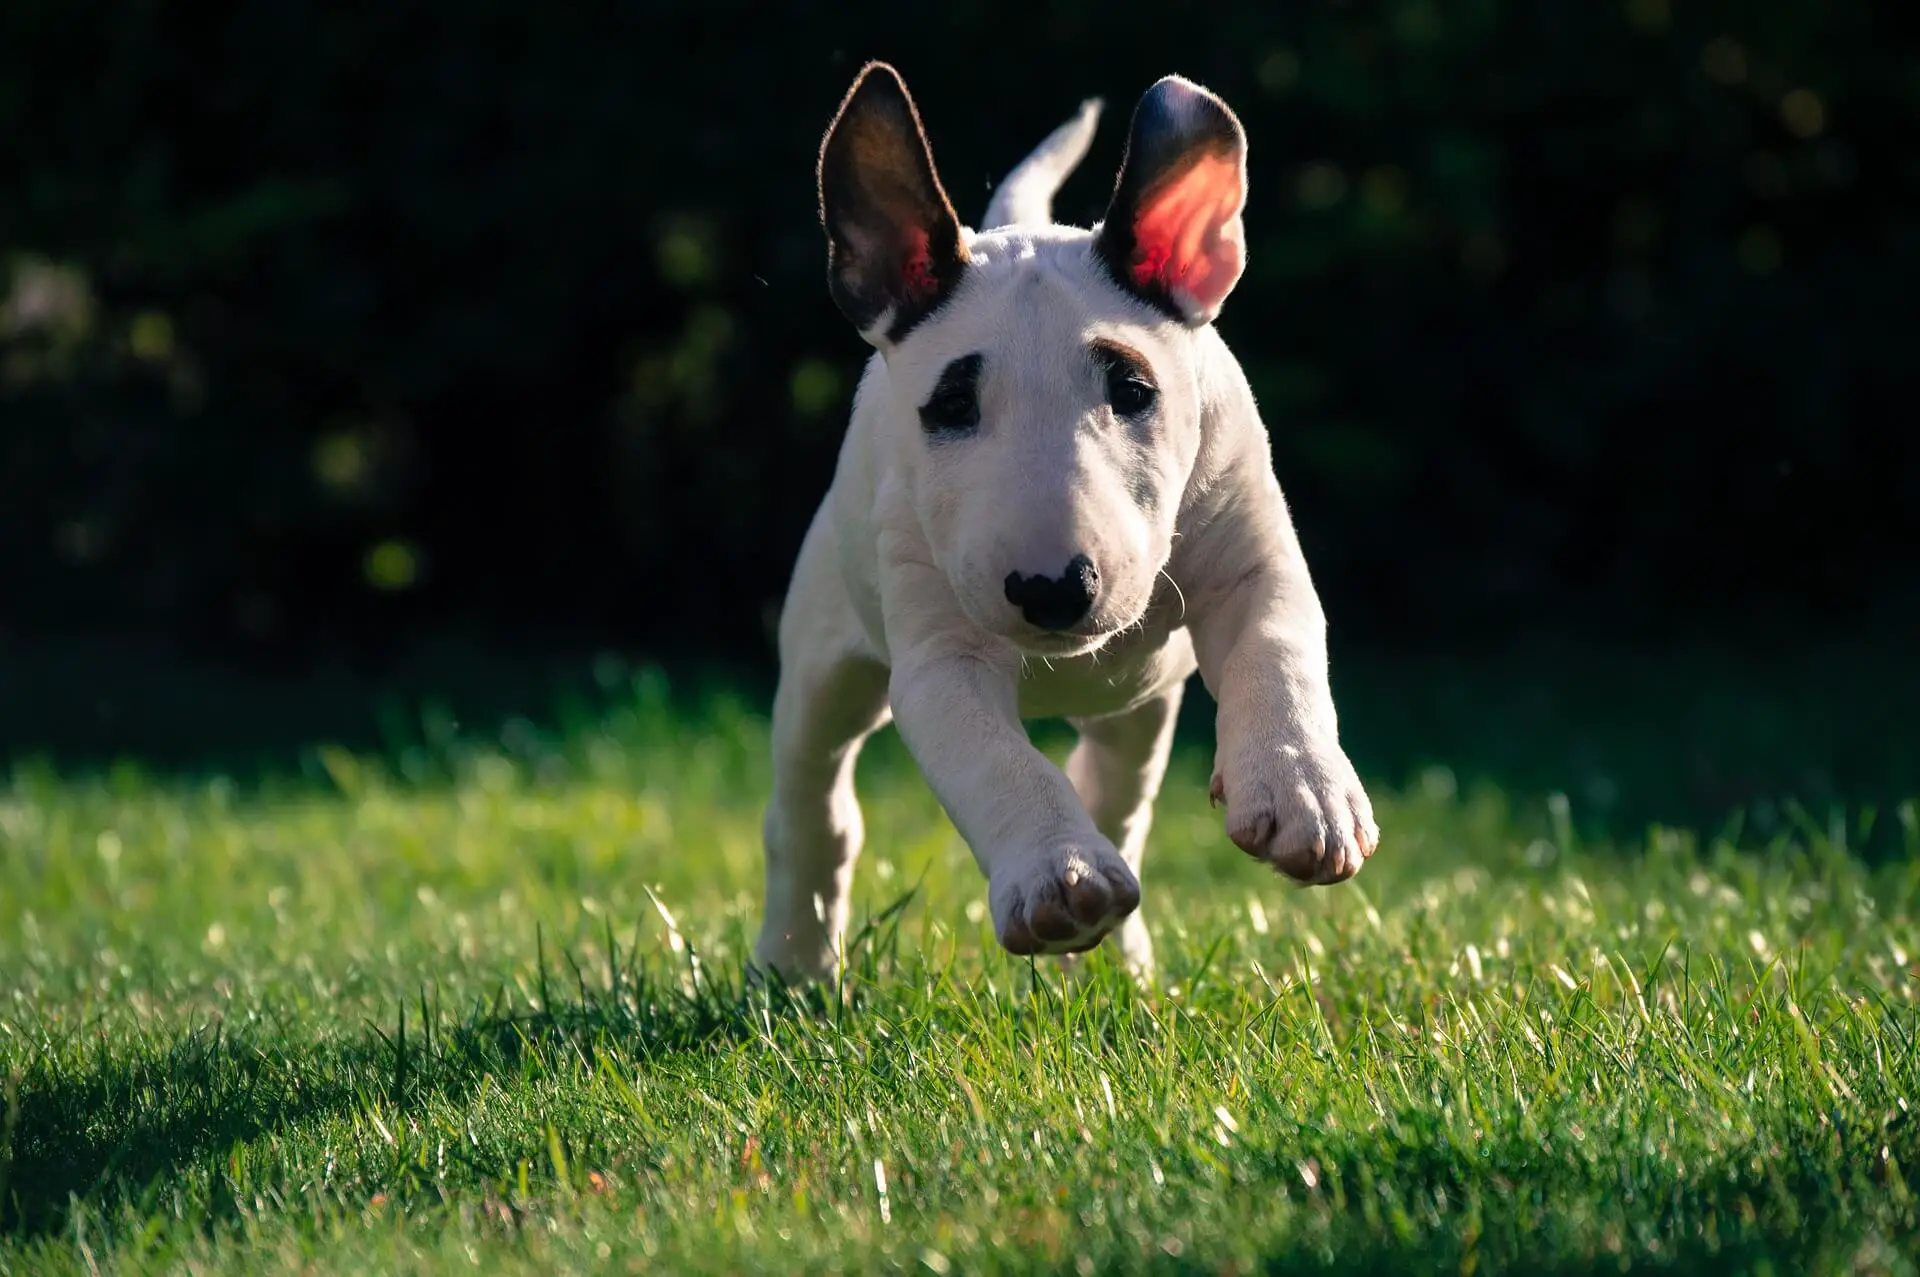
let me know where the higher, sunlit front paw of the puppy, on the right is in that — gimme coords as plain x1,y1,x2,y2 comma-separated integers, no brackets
1212,745,1380,885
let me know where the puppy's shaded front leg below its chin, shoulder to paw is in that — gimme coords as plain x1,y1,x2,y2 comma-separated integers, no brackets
891,639,1140,954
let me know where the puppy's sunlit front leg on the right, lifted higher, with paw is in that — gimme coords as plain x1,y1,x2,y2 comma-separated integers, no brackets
1190,480,1380,883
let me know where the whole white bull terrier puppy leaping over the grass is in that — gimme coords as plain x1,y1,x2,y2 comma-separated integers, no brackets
755,63,1379,979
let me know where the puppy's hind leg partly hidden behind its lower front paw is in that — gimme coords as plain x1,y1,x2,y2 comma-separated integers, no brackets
1068,682,1187,976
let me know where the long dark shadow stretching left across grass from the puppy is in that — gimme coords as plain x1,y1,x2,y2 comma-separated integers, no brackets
0,968,779,1239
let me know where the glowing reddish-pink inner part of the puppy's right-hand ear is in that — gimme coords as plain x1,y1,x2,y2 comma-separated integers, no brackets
1133,156,1246,317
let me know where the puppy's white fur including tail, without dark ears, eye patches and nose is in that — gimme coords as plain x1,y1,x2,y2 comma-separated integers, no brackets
755,82,1379,979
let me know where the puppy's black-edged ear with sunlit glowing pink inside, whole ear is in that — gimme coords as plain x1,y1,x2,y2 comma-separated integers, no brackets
1094,75,1246,328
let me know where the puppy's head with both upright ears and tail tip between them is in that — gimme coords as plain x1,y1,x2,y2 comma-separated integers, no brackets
820,63,1246,655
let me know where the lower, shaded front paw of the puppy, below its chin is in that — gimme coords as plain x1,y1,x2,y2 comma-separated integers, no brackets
987,845,1140,954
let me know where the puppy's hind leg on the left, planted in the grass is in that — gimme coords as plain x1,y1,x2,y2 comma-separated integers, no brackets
753,518,887,981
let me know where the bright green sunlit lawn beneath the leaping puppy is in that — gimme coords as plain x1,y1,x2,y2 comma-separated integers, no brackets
0,680,1920,1275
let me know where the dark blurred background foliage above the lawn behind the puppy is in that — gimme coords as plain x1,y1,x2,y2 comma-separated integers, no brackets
0,0,1920,837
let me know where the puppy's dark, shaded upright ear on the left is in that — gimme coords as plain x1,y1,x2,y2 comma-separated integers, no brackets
820,61,968,346
